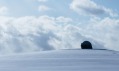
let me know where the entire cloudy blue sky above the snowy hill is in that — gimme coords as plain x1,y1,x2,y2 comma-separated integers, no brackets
0,0,119,54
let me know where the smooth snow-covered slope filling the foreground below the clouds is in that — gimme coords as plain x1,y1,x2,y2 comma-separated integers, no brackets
0,49,119,71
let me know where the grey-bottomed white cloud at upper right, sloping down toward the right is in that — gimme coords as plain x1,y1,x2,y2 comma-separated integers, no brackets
70,0,118,17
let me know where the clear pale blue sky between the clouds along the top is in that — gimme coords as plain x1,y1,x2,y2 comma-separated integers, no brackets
0,0,119,17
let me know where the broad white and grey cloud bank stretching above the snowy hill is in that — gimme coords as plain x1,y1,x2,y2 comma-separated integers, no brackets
0,15,119,54
